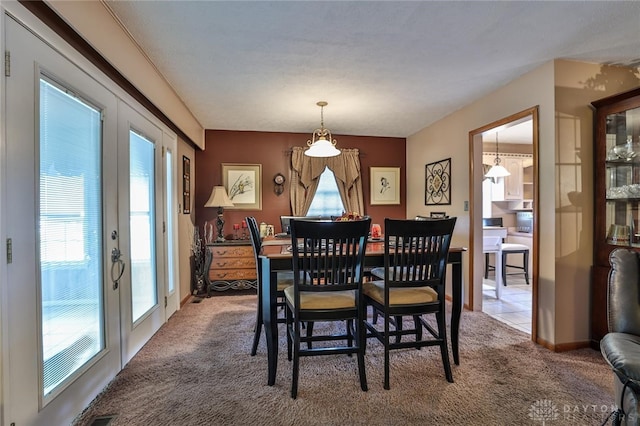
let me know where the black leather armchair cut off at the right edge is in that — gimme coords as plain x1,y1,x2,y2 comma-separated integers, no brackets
600,248,640,425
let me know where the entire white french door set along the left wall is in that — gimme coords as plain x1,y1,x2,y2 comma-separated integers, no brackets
0,16,177,425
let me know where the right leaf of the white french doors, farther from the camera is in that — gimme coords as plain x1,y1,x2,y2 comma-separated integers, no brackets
114,102,165,365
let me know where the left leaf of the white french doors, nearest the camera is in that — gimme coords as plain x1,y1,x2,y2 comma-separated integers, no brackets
2,18,121,425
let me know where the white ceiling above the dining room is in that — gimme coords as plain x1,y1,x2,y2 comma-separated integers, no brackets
103,0,640,137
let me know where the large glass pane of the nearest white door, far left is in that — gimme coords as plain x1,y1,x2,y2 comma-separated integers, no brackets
38,78,105,395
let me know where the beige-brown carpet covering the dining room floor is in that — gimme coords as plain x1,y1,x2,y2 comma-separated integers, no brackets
74,295,614,426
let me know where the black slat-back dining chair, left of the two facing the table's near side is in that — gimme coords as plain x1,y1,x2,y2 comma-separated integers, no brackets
284,218,371,399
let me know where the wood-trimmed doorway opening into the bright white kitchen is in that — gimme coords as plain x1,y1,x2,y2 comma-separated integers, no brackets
469,107,539,341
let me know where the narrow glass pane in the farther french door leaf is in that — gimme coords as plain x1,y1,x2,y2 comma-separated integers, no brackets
129,131,158,323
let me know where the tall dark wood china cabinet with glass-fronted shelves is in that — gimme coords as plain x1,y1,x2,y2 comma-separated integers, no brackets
591,89,640,348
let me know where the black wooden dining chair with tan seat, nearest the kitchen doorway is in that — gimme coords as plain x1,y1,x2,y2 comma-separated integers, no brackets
363,218,456,389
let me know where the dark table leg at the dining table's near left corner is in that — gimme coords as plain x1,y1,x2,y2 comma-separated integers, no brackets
260,257,278,386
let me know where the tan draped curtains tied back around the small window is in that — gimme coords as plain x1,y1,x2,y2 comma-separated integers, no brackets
290,147,364,216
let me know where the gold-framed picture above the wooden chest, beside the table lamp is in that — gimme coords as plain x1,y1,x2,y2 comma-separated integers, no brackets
222,163,262,210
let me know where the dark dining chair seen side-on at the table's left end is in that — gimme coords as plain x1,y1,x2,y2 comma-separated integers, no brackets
245,216,293,356
